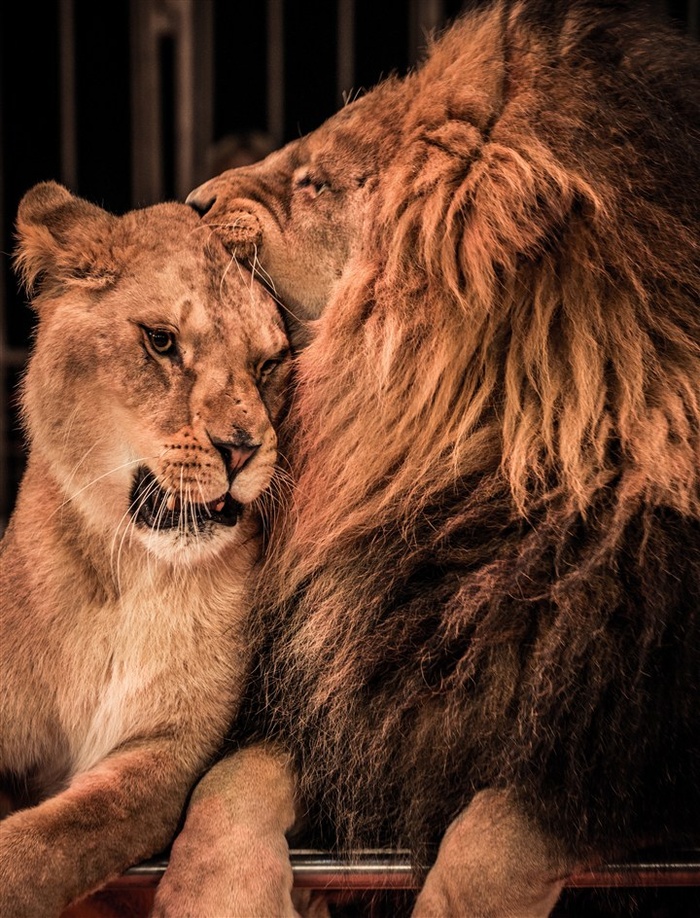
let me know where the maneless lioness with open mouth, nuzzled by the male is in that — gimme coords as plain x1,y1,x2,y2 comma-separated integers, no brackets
0,182,290,918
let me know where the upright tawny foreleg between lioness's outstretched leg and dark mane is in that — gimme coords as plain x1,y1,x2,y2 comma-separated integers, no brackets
153,746,304,918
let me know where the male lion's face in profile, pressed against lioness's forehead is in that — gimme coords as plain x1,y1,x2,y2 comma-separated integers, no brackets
187,81,400,331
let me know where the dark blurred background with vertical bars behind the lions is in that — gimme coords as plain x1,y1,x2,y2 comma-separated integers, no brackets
0,0,700,533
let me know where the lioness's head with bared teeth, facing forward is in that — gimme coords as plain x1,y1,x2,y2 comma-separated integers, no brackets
16,182,288,559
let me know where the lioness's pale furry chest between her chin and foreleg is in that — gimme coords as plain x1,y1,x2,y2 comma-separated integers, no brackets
0,544,249,793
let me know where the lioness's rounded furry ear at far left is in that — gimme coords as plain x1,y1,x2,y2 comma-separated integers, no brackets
14,182,117,304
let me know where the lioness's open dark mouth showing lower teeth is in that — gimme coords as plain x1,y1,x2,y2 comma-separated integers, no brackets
131,466,243,529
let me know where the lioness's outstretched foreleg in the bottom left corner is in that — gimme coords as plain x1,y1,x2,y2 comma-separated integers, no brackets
0,742,192,918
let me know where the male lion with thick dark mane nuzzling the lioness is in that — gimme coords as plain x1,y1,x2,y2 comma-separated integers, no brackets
157,0,700,918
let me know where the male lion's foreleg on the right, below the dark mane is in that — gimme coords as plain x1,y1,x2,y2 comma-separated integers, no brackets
413,791,573,918
